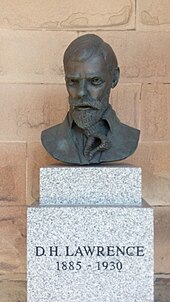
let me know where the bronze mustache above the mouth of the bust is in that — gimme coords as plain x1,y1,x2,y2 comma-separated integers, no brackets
69,98,101,110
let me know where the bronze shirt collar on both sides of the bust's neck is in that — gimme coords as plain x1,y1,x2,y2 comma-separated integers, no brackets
68,104,119,132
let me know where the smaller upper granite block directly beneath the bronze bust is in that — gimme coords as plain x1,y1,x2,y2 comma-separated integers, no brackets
40,164,141,205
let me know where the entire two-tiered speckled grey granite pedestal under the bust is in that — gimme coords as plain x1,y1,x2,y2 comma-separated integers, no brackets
27,166,154,302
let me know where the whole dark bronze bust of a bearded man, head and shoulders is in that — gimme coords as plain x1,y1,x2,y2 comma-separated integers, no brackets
41,34,140,165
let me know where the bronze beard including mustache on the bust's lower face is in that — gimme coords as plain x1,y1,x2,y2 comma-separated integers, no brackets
69,97,107,129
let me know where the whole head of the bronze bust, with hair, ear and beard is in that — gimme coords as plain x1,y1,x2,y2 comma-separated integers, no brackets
64,34,119,129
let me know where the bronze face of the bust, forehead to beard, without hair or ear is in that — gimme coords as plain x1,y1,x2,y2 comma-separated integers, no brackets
65,55,112,129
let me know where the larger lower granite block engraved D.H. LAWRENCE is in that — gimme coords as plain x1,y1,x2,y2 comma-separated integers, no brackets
27,206,153,302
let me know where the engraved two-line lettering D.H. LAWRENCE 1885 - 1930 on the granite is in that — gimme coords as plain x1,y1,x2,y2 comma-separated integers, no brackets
35,245,145,272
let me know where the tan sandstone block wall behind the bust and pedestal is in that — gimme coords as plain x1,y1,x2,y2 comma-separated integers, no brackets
0,0,170,302
